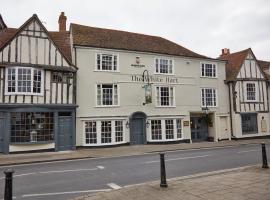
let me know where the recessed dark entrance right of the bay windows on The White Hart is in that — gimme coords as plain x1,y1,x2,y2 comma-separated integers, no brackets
190,117,208,142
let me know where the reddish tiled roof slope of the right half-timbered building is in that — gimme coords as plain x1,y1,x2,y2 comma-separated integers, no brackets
219,49,251,81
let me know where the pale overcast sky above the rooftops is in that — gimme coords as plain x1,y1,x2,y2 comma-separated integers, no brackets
0,0,270,61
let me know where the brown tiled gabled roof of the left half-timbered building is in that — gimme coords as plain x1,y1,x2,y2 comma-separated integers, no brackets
0,14,73,65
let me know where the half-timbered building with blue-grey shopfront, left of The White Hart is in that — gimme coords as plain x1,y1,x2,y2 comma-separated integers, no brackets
0,13,76,153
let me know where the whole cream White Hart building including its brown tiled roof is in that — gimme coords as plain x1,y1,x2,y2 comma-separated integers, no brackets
70,24,231,146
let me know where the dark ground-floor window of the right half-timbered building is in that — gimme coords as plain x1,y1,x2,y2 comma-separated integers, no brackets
241,113,258,135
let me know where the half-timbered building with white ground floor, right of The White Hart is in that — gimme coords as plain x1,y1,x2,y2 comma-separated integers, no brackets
221,48,270,138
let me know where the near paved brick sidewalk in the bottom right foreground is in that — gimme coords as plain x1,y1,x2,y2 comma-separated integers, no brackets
76,166,270,200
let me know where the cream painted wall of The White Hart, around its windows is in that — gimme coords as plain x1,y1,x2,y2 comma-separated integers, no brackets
76,47,229,145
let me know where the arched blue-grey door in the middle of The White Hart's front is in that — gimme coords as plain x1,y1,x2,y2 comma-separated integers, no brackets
130,112,146,144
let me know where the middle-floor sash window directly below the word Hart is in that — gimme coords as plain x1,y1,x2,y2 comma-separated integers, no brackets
156,87,174,106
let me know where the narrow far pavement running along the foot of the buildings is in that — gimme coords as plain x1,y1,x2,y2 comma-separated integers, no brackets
0,139,270,166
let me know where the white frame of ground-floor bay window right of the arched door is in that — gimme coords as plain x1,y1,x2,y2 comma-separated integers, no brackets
147,117,183,142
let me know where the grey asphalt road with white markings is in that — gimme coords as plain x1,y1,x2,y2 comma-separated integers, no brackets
0,145,270,200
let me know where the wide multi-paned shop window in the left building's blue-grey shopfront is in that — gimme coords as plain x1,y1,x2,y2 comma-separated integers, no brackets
10,112,54,143
